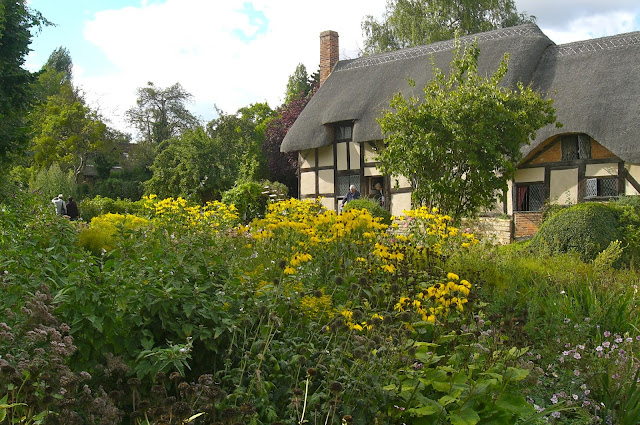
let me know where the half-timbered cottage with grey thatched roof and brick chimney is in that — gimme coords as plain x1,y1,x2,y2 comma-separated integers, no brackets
281,24,640,234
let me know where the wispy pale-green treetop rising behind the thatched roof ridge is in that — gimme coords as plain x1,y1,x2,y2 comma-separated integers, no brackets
362,0,535,54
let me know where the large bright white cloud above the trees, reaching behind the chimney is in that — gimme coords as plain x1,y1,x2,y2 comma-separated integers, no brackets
76,0,385,136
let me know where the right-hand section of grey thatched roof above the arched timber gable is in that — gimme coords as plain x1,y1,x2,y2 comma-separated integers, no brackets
523,32,640,163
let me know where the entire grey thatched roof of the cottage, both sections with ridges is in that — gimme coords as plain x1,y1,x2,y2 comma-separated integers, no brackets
281,24,640,162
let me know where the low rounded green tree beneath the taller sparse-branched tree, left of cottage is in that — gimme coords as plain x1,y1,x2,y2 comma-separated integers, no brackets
144,127,237,203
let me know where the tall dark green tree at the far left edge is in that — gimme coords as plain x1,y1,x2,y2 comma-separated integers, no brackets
0,0,48,163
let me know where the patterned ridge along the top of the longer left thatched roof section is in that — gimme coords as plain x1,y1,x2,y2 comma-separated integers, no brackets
334,23,544,72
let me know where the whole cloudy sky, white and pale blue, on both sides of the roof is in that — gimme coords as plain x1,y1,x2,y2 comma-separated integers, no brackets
27,0,640,138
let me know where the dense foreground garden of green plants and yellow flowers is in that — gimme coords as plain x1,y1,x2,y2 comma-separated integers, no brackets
0,186,640,424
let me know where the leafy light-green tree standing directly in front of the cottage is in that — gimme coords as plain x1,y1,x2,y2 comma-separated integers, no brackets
379,40,556,217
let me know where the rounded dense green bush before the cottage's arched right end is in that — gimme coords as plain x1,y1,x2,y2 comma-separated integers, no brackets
529,202,622,261
